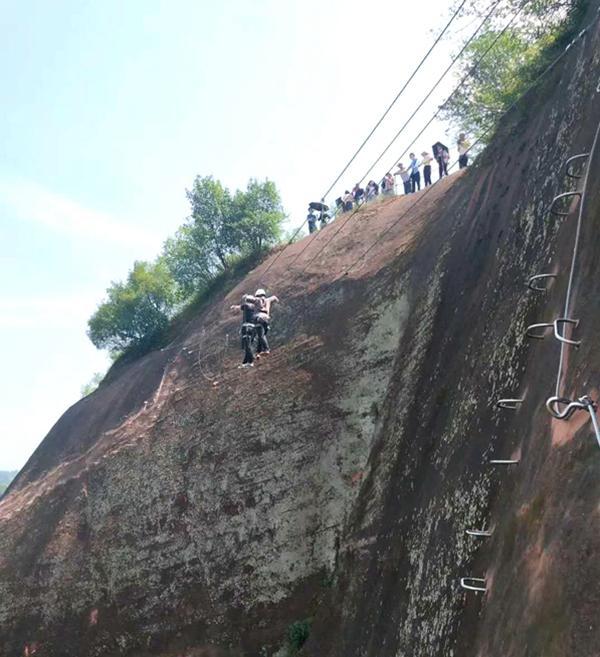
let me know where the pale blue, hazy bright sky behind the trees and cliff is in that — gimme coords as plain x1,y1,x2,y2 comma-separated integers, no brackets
0,0,470,469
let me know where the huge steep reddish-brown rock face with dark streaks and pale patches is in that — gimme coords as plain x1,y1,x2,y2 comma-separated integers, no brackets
0,12,600,657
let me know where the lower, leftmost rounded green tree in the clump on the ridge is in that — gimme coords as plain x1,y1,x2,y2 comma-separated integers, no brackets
88,258,176,353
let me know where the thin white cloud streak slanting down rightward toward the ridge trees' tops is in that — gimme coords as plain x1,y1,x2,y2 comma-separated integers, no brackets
0,180,162,250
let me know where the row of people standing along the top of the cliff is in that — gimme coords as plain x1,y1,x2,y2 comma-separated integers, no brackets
307,133,471,233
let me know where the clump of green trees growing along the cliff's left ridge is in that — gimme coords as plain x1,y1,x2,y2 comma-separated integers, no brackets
88,176,285,356
